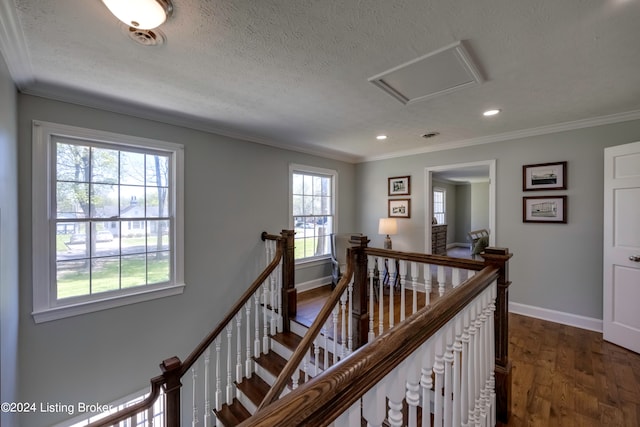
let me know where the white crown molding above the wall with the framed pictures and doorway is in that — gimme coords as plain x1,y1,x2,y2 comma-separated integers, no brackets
360,110,640,163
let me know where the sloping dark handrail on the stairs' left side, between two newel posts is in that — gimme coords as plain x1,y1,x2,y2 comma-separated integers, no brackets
180,233,283,376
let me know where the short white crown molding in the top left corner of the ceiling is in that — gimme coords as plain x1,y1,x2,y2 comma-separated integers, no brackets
0,0,34,89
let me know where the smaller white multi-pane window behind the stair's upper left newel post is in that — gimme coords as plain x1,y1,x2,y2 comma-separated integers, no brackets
290,165,337,260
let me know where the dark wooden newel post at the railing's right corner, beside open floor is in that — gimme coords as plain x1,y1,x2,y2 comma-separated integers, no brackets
480,247,513,424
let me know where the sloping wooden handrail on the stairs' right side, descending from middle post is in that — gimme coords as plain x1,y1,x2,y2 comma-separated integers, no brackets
257,237,362,412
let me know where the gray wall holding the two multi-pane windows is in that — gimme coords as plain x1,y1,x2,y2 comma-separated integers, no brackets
16,95,355,427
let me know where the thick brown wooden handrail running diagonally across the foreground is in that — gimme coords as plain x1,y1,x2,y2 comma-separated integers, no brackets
239,266,499,427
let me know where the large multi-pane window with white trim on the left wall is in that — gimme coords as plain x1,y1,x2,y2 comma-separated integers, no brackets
33,123,183,321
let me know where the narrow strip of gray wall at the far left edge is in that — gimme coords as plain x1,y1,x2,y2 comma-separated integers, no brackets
0,49,19,426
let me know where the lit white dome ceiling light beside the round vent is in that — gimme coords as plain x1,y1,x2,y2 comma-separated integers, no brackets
102,0,173,30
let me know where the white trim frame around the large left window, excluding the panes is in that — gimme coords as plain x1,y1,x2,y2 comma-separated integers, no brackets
31,120,185,323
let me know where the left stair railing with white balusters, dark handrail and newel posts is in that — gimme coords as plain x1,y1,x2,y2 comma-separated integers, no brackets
90,230,296,427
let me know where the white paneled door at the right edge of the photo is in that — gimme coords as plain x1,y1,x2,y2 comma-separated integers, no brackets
603,142,640,353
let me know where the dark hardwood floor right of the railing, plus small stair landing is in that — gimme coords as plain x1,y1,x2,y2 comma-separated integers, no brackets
298,287,640,427
